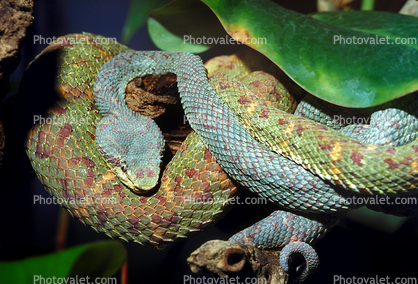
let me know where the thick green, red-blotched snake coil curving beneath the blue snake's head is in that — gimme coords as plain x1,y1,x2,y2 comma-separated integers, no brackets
25,33,236,246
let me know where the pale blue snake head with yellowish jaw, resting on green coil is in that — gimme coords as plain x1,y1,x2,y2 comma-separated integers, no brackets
96,112,164,193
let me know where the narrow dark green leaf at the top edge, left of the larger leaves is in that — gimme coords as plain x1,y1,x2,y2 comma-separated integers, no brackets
122,0,170,44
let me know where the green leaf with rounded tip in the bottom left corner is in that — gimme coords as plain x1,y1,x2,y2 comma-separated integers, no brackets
0,241,126,284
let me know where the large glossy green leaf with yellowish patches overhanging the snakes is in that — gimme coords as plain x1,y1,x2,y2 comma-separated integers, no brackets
149,0,418,107
